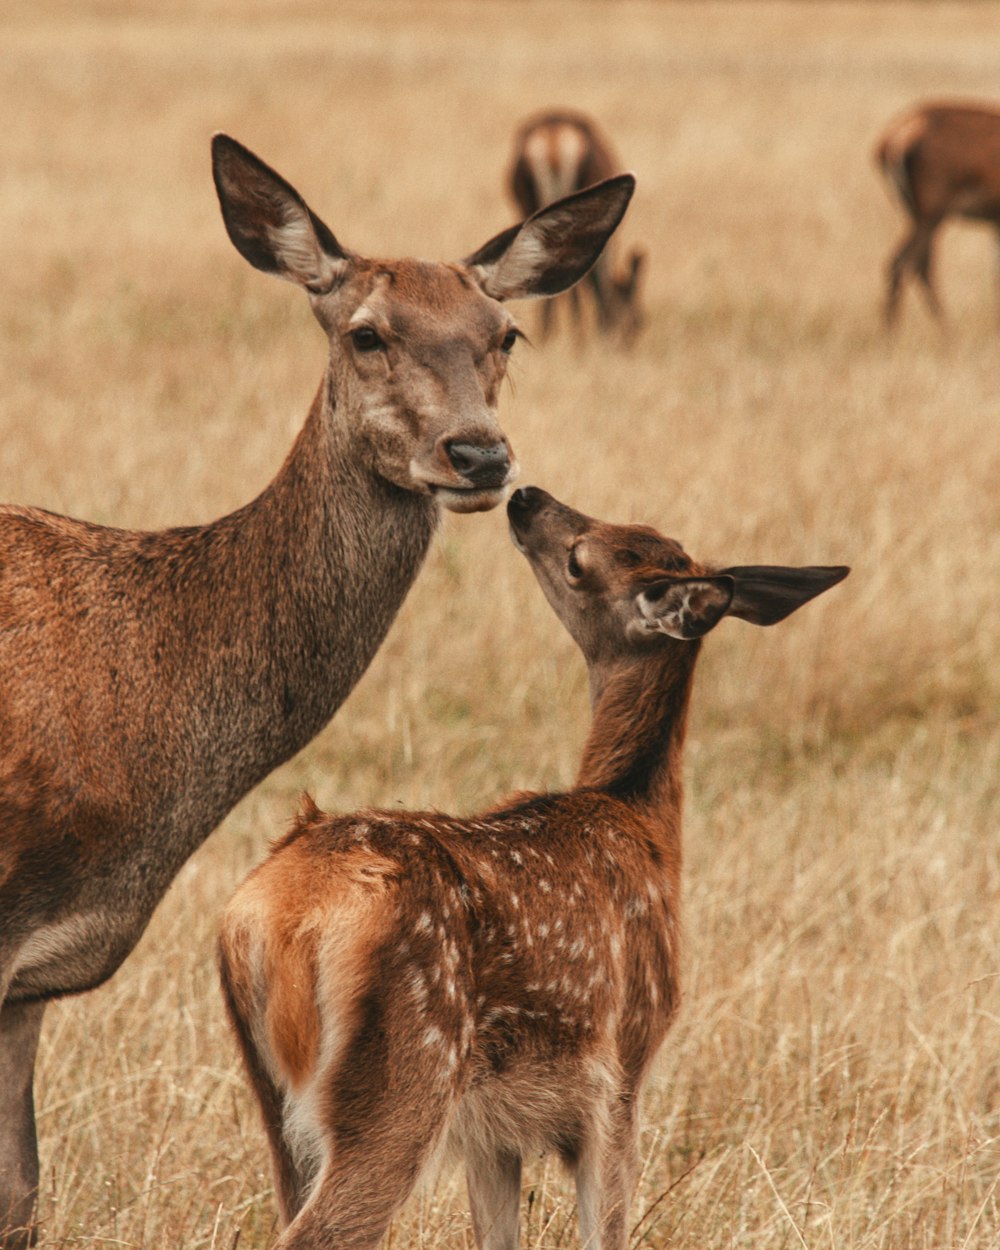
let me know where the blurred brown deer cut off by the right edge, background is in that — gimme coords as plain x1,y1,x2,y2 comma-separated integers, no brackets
875,104,1000,326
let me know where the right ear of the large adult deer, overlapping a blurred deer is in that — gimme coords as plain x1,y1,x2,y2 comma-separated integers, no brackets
463,174,635,300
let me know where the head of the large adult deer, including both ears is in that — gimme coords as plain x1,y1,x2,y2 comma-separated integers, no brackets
213,135,634,513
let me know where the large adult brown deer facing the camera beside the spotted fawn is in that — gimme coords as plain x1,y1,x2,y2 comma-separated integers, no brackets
0,135,634,1248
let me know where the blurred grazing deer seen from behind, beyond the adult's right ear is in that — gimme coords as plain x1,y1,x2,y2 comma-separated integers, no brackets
509,113,646,344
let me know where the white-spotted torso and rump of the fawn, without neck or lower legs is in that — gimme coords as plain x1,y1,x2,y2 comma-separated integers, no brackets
223,791,679,1168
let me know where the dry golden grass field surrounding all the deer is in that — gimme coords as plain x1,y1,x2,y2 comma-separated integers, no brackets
0,0,1000,1250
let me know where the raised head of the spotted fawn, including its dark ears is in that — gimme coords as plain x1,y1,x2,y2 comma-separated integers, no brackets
508,486,850,664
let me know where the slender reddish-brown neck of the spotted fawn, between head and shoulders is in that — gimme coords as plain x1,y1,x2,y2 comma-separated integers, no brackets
576,643,700,823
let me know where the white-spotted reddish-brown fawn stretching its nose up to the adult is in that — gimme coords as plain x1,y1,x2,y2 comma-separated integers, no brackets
220,489,848,1250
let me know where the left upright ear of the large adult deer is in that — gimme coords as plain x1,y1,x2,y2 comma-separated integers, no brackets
211,134,353,294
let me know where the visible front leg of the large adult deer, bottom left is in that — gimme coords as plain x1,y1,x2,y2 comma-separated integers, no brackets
0,1003,45,1250
